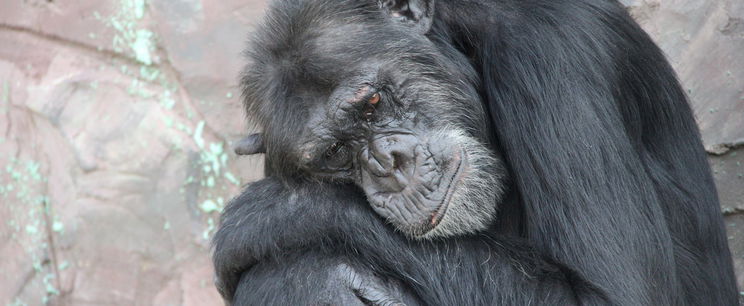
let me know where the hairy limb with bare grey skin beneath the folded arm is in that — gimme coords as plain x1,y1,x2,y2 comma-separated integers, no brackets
233,251,421,306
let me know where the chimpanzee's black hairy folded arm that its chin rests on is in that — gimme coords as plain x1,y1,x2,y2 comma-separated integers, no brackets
214,178,604,305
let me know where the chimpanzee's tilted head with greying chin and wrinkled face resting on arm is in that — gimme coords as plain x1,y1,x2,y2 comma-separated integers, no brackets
242,0,506,238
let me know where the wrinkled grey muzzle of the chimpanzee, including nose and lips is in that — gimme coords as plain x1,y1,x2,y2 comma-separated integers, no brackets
359,135,469,238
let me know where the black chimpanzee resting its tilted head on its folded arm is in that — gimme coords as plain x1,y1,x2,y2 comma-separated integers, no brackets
214,0,737,305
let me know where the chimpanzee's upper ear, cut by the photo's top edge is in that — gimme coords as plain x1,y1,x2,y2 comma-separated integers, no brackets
379,0,435,34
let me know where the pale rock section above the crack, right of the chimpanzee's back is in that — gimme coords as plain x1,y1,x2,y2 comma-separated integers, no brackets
631,0,744,154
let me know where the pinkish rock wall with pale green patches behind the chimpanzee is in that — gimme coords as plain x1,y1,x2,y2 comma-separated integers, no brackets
0,0,744,305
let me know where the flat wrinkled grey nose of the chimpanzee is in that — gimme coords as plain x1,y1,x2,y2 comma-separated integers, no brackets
362,134,419,177
